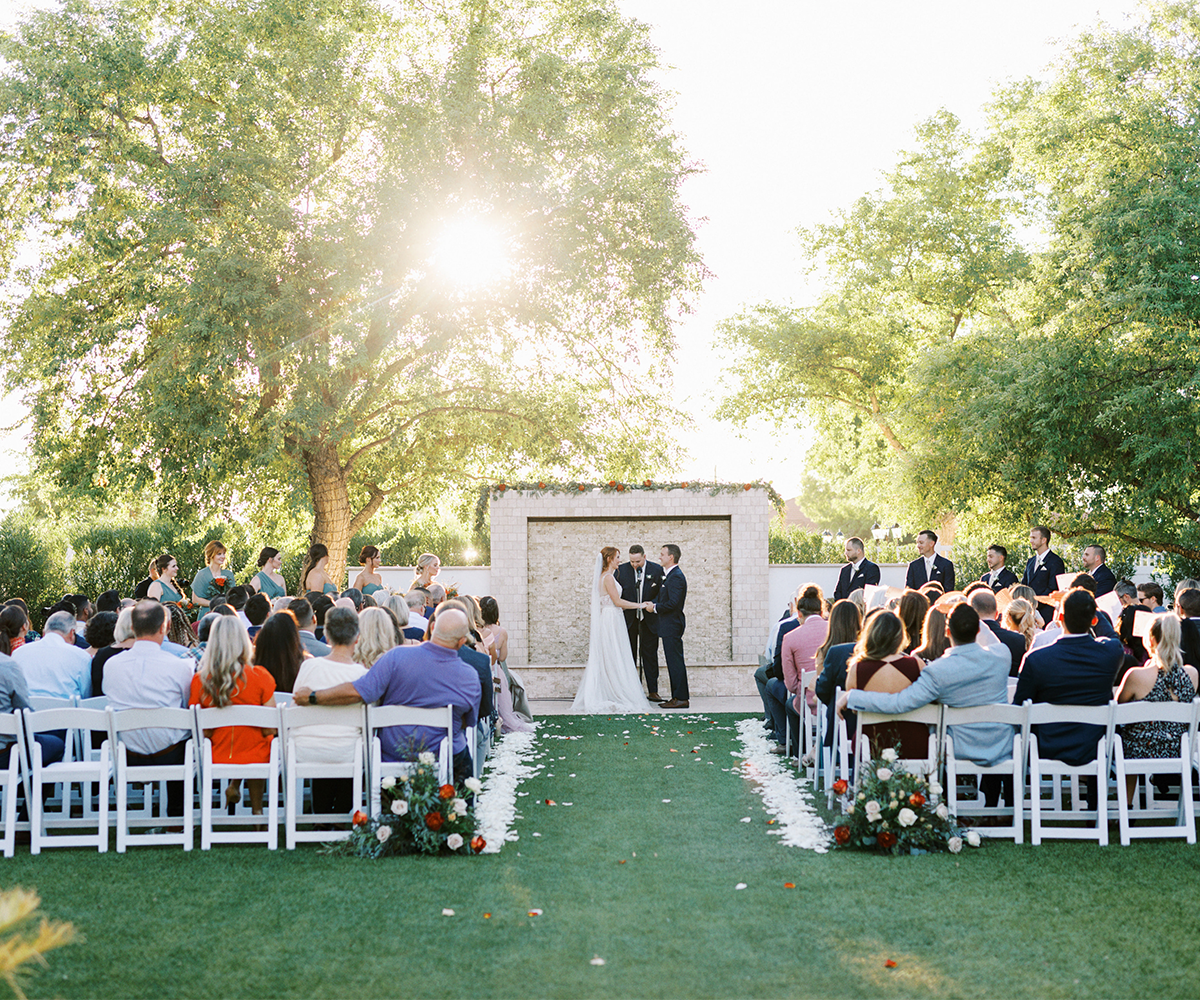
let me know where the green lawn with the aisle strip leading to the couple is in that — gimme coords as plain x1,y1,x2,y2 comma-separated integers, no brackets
0,715,1200,1000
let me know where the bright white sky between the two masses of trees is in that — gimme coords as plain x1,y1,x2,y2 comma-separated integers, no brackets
0,0,1135,504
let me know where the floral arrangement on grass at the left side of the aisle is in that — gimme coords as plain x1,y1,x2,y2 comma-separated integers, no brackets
326,752,487,857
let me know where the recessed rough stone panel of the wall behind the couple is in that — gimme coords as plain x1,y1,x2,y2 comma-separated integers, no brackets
527,517,733,670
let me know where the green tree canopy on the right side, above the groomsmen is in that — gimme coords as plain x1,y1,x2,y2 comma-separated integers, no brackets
725,4,1200,569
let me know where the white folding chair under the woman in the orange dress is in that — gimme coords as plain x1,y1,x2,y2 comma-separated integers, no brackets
196,705,281,851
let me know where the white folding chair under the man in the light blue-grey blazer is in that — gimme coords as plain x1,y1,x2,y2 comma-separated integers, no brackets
942,701,1031,844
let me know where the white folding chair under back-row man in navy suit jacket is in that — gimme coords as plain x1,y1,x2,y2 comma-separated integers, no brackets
1028,702,1116,846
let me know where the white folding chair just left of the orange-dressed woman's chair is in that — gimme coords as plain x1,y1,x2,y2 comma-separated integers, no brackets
108,708,196,855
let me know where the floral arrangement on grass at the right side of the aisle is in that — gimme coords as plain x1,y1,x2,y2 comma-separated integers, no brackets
833,749,980,854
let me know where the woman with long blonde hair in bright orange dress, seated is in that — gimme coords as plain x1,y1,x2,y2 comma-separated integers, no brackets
190,616,275,815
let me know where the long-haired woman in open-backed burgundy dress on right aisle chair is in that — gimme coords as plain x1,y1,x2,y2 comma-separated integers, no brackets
846,611,929,760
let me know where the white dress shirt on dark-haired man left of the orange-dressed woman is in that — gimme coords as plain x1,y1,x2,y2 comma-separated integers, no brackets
104,639,194,754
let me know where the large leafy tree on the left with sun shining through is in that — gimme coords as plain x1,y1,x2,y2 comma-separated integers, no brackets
0,0,703,571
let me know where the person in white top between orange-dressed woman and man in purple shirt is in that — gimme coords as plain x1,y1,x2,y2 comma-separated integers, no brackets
295,607,371,813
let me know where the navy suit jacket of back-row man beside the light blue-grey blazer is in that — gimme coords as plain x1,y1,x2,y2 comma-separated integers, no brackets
1013,634,1124,766
